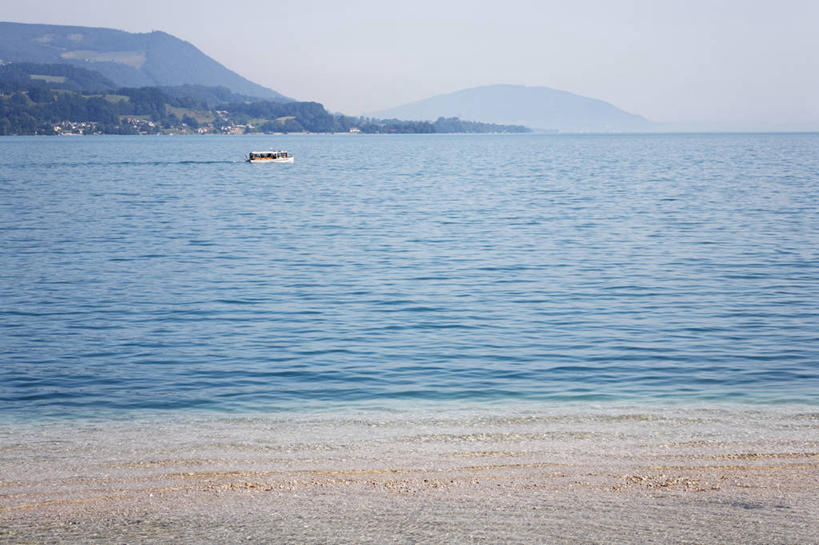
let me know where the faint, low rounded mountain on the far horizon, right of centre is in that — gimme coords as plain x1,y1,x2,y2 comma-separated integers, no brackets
368,85,654,132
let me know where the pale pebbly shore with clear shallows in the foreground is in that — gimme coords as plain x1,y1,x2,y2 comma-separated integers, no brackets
0,405,819,543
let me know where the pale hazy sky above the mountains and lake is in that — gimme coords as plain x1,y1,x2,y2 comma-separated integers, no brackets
0,0,819,130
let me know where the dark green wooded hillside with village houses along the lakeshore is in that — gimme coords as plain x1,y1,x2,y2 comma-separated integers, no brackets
0,79,352,135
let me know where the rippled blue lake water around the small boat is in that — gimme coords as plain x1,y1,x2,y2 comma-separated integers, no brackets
0,134,819,416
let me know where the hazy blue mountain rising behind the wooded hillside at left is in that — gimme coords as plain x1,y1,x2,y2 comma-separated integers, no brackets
0,22,291,101
